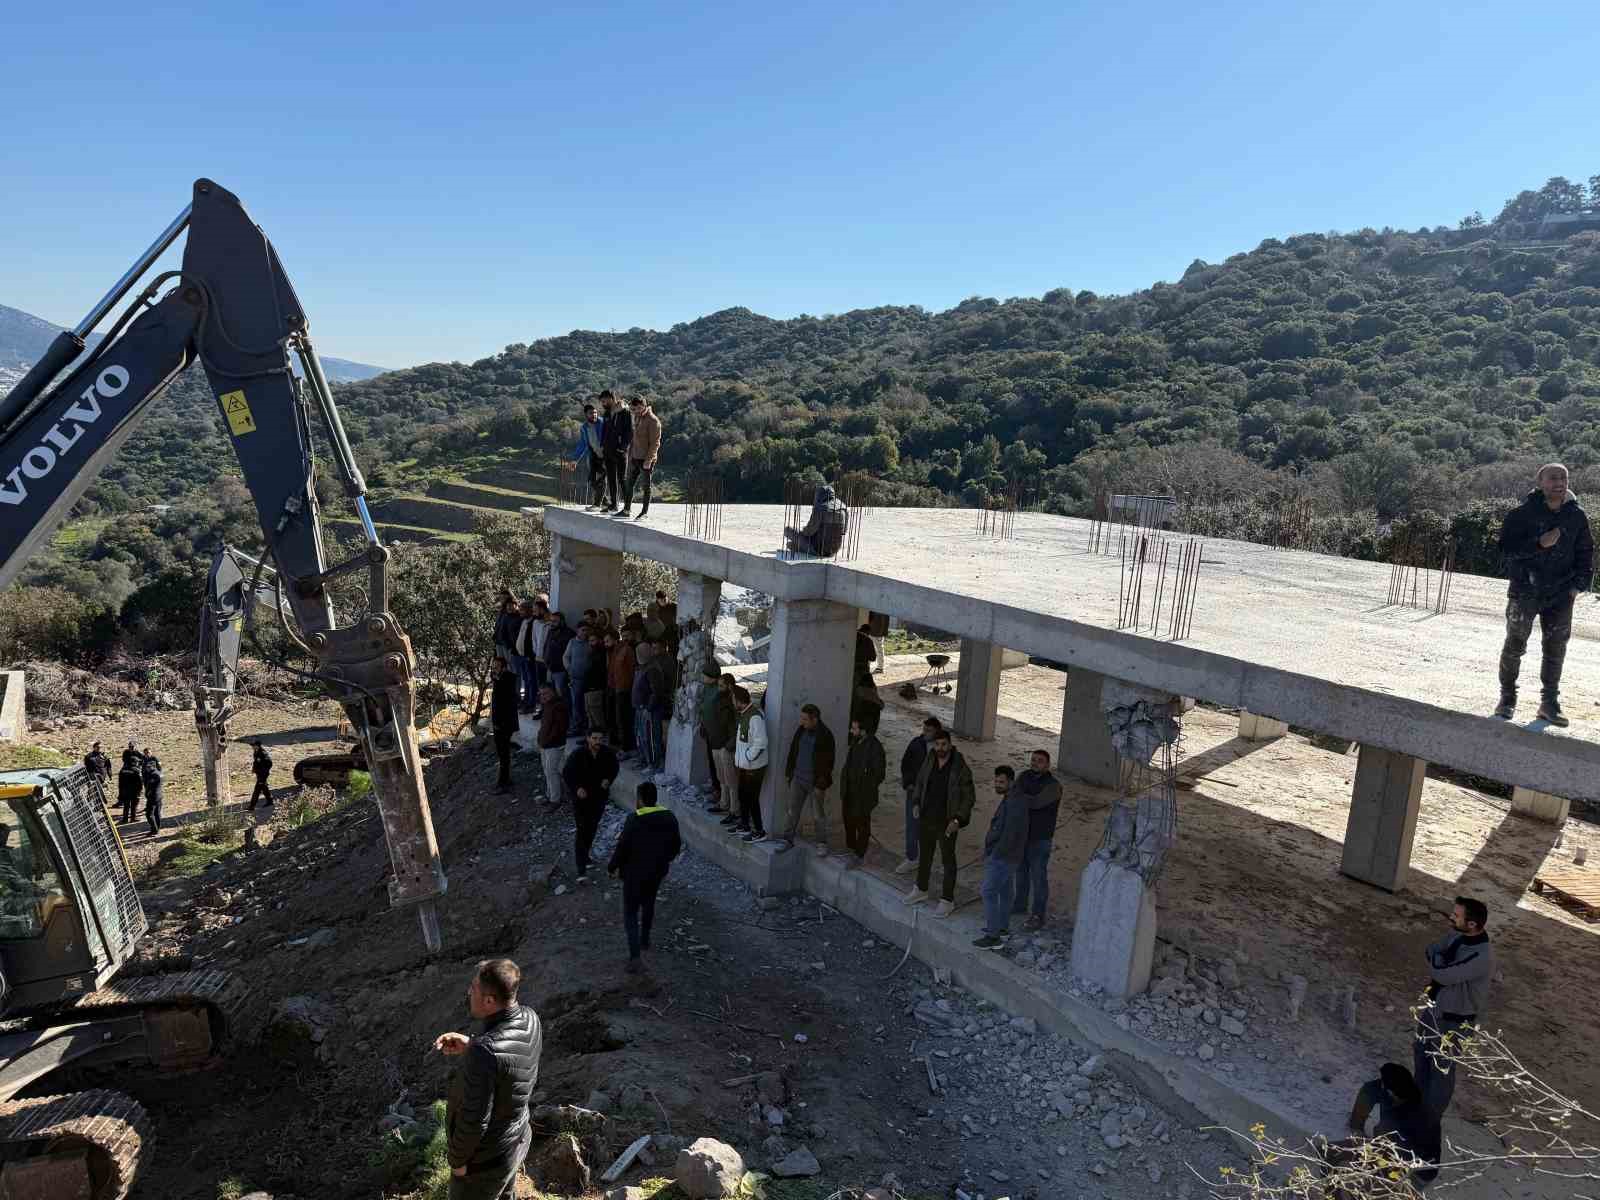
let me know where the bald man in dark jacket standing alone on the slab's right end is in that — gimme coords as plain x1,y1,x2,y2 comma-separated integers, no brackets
1494,462,1595,725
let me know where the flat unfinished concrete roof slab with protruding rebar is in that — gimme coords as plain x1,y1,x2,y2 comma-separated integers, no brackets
542,504,1600,798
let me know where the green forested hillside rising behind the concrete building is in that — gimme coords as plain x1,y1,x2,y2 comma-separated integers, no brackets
9,176,1600,668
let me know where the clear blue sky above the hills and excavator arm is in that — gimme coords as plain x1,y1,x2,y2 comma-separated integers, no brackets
0,0,1600,366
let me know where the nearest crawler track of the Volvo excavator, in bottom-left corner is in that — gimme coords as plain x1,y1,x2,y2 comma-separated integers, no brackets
0,1088,154,1200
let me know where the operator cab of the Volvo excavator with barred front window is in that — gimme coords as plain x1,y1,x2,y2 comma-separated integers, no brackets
0,766,146,1011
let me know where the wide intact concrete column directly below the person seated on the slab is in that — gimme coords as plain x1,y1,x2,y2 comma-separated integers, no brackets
762,600,861,832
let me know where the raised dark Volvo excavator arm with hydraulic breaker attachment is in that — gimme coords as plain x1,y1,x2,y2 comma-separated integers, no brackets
0,179,445,950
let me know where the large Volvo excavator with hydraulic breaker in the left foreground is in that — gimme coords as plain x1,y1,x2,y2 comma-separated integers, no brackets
0,179,445,1200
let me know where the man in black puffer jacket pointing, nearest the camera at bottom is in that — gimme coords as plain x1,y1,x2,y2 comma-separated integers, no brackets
434,958,544,1200
